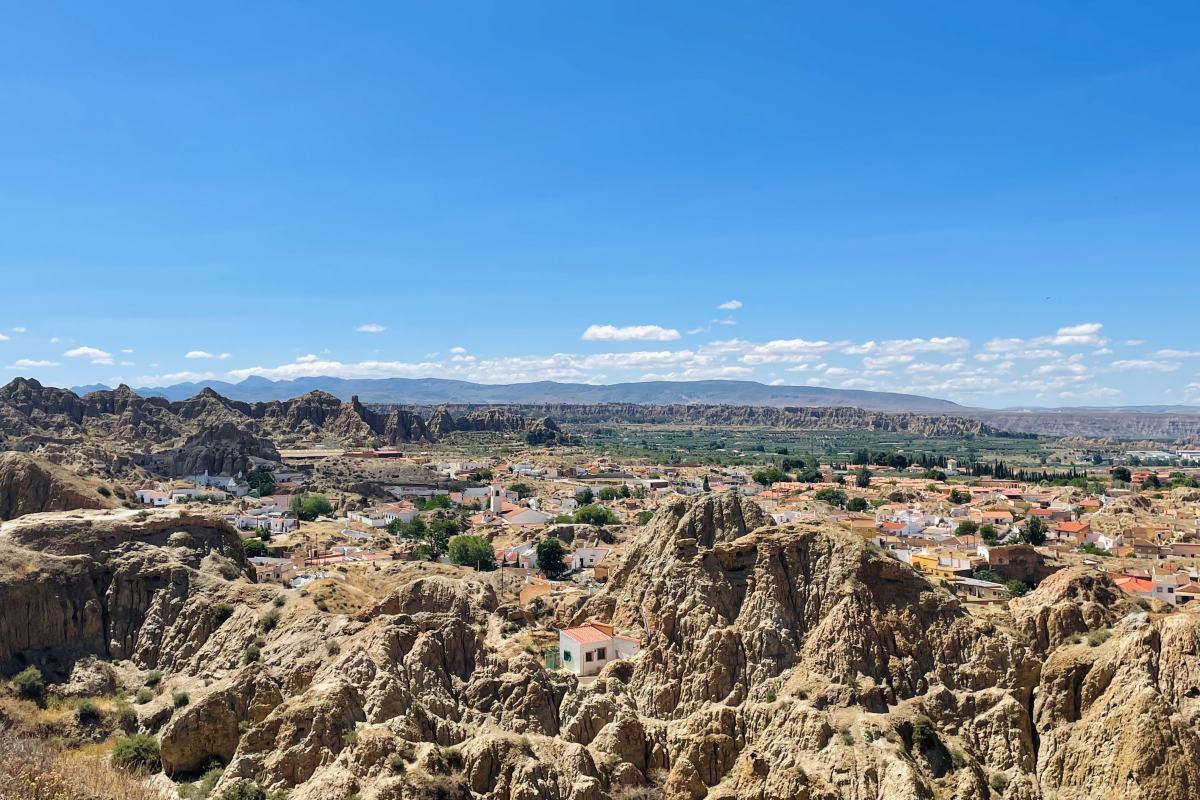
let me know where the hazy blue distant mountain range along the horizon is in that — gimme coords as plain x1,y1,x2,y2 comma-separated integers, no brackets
103,378,964,414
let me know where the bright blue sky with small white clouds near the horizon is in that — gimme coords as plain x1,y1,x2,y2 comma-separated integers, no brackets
0,2,1200,407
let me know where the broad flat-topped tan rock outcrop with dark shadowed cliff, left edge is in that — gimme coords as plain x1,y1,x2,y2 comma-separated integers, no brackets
0,511,247,676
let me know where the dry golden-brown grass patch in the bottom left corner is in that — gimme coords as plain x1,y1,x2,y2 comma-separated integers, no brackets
0,729,162,800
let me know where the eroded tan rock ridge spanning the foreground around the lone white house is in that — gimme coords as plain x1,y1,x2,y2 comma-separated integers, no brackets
0,495,1200,800
